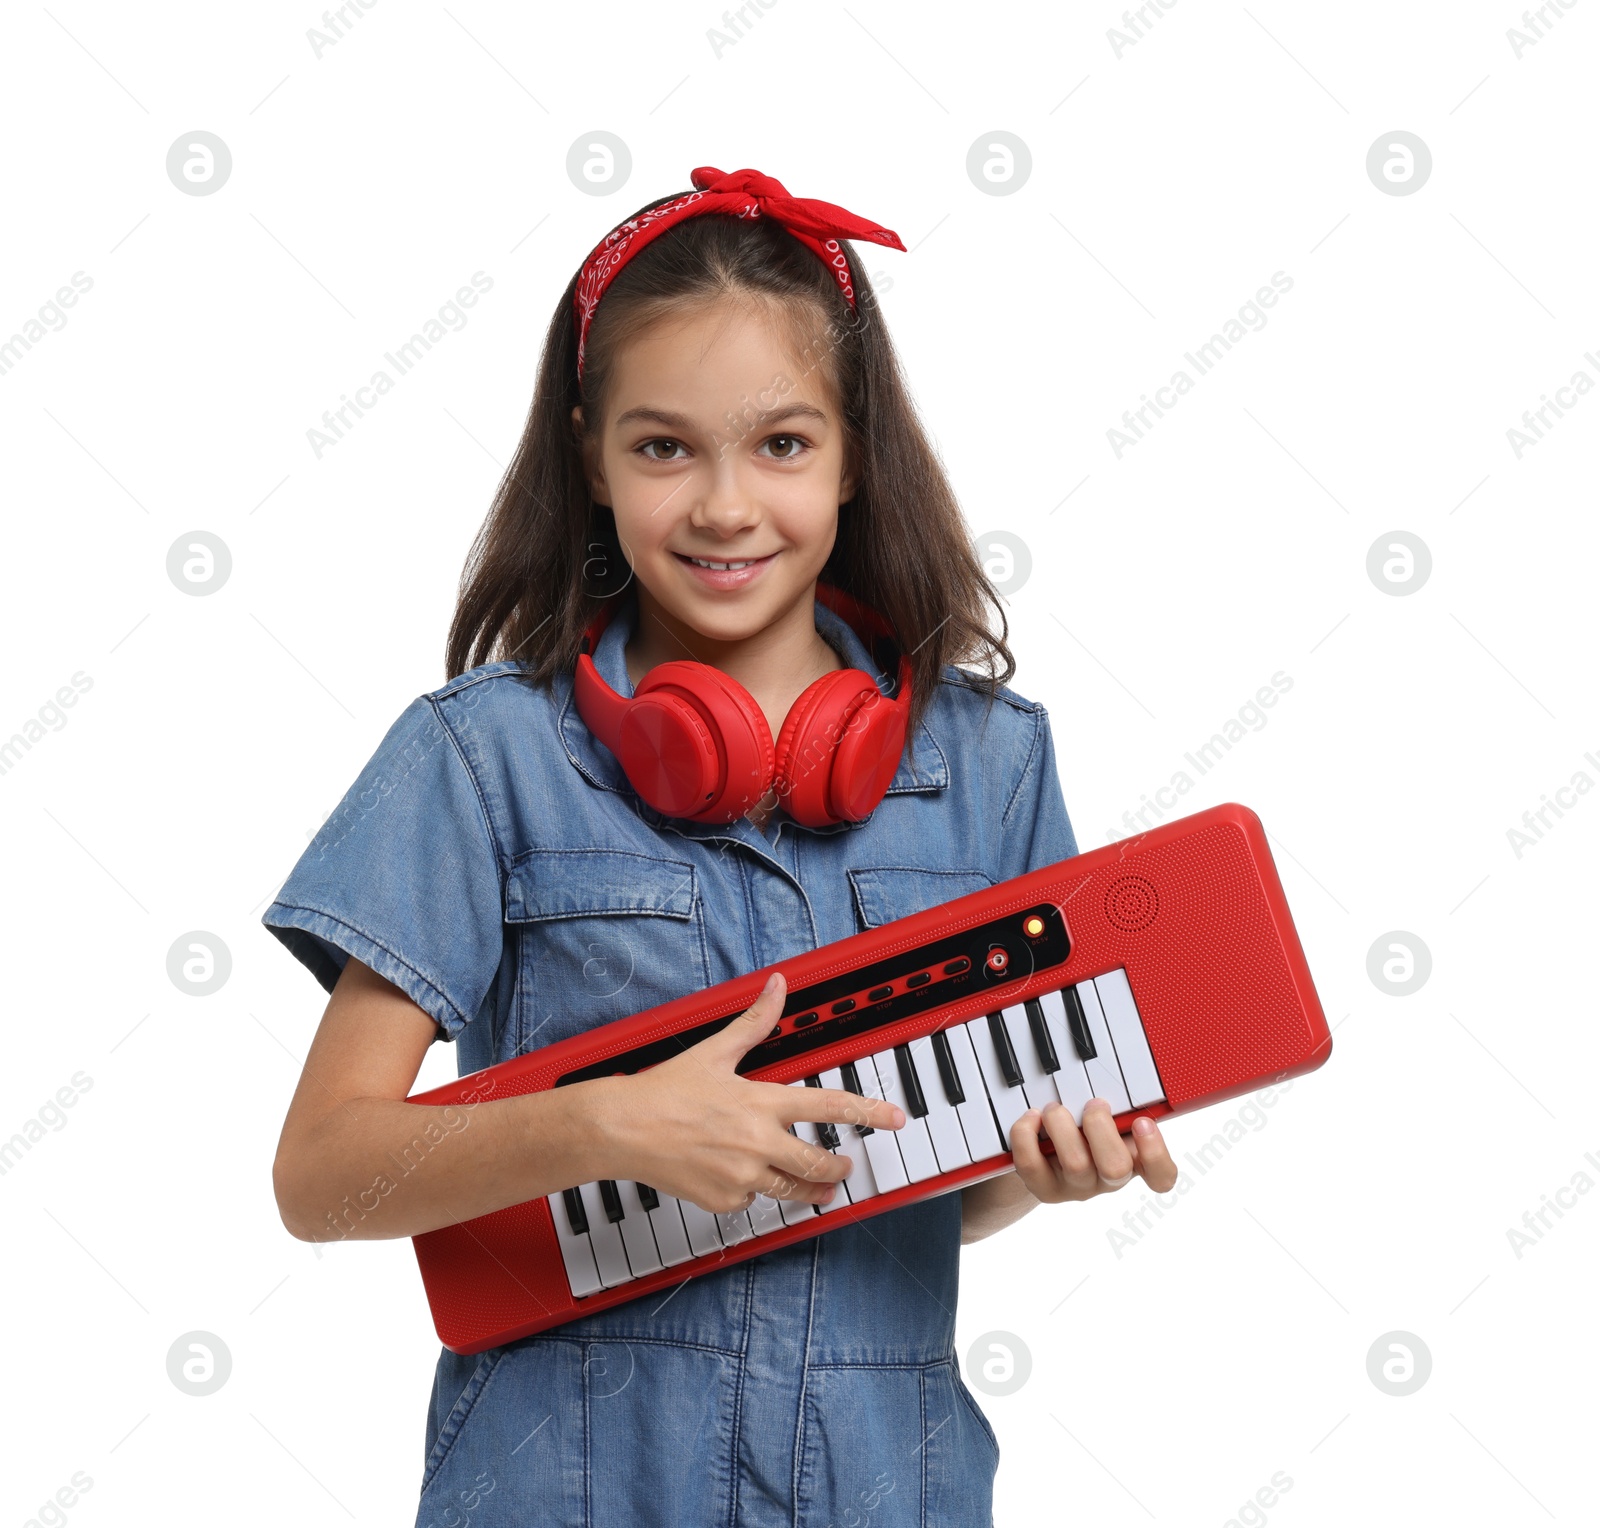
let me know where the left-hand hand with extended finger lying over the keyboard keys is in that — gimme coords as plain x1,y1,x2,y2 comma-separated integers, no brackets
597,973,906,1214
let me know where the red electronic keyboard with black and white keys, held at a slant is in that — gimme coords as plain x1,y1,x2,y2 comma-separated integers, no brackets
410,803,1331,1354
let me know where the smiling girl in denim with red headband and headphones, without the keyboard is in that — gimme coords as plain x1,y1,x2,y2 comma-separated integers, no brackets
264,170,1176,1528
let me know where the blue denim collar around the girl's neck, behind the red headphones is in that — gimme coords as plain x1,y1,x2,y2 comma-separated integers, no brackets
557,600,950,840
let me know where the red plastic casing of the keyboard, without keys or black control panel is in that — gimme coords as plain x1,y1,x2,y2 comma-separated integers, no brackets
410,803,1331,1354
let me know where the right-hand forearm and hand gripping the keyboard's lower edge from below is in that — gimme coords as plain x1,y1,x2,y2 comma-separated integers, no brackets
962,1098,1178,1245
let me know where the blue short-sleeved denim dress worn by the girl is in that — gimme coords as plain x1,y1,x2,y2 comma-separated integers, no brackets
262,605,1077,1528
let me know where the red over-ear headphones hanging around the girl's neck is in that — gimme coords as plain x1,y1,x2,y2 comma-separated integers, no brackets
573,584,910,827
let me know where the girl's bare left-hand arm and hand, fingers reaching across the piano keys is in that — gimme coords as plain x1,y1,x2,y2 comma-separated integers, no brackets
272,957,906,1242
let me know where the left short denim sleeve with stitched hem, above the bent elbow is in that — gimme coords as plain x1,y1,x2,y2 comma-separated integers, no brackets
261,696,504,1040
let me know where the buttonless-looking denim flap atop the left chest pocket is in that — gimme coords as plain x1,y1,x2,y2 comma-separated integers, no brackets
506,850,698,923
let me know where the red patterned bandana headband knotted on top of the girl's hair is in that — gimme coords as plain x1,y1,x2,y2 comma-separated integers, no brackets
576,165,906,382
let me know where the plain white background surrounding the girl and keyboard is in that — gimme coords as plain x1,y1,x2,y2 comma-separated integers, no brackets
0,0,1600,1528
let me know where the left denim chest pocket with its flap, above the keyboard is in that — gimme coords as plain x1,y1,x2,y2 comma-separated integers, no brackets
501,848,710,1059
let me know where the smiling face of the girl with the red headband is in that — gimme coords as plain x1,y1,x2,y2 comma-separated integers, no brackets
574,301,854,643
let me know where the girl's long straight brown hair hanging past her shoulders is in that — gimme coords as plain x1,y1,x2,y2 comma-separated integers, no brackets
445,188,1016,726
